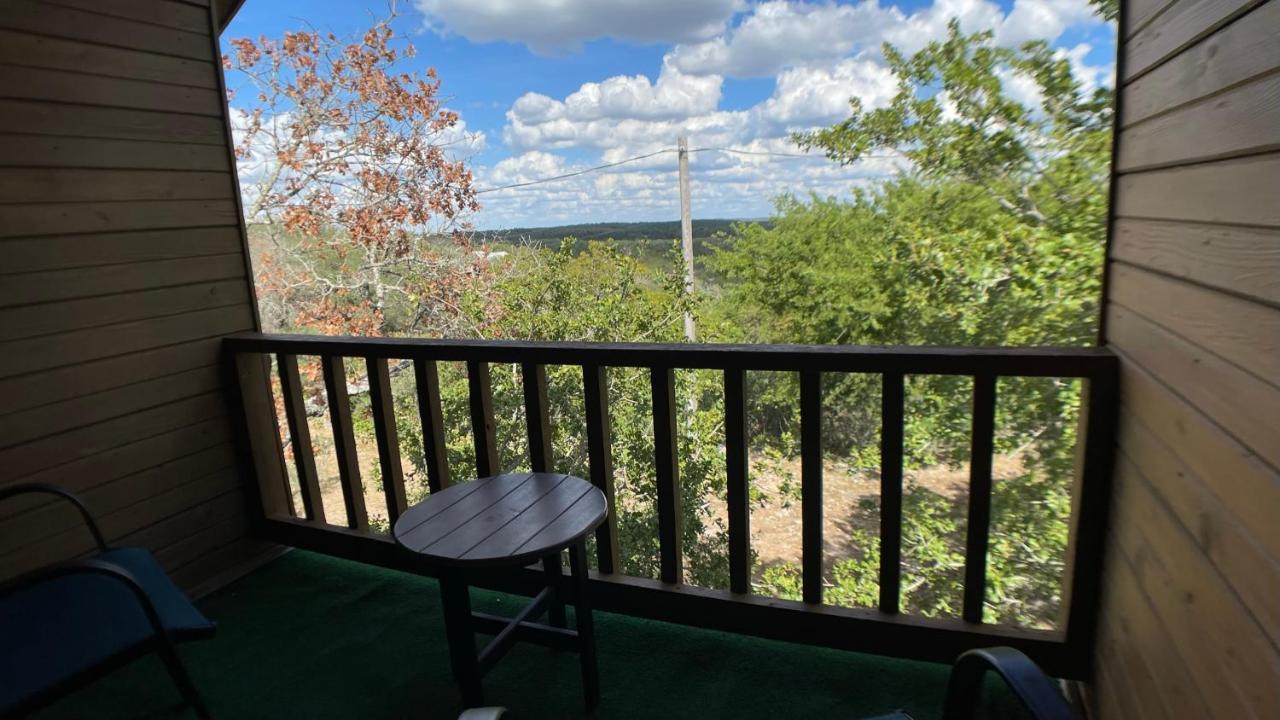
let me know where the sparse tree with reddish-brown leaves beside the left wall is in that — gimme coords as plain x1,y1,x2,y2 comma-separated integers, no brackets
223,18,484,334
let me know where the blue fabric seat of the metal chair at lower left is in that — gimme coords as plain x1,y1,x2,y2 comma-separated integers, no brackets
0,548,214,714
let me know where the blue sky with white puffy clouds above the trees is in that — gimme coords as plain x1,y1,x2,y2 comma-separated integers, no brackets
223,0,1115,228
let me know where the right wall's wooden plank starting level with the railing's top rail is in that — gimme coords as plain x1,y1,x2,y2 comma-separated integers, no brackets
1107,305,1280,468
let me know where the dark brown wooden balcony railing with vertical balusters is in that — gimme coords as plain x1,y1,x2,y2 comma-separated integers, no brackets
224,334,1117,678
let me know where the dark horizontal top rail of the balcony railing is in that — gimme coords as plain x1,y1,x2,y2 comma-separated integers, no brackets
224,333,1116,378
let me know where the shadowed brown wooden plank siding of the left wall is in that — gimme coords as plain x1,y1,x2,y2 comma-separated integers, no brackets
0,0,264,588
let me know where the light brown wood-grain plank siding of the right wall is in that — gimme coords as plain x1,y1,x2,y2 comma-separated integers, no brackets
1093,0,1280,719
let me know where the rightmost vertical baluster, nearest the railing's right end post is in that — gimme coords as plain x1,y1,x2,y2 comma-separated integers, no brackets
963,373,996,623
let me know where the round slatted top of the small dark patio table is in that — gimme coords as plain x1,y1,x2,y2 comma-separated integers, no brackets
392,473,608,566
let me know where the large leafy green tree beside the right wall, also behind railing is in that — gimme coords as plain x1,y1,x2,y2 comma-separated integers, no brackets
713,23,1111,624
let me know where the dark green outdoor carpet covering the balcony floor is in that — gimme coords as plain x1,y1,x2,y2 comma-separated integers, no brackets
38,551,1018,720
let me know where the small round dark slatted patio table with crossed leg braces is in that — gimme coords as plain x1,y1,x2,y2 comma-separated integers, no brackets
392,473,608,712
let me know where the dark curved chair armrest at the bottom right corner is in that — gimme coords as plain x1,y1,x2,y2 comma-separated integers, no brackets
942,647,1079,720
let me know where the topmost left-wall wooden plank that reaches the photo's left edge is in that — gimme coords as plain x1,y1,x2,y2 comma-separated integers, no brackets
0,0,214,61
